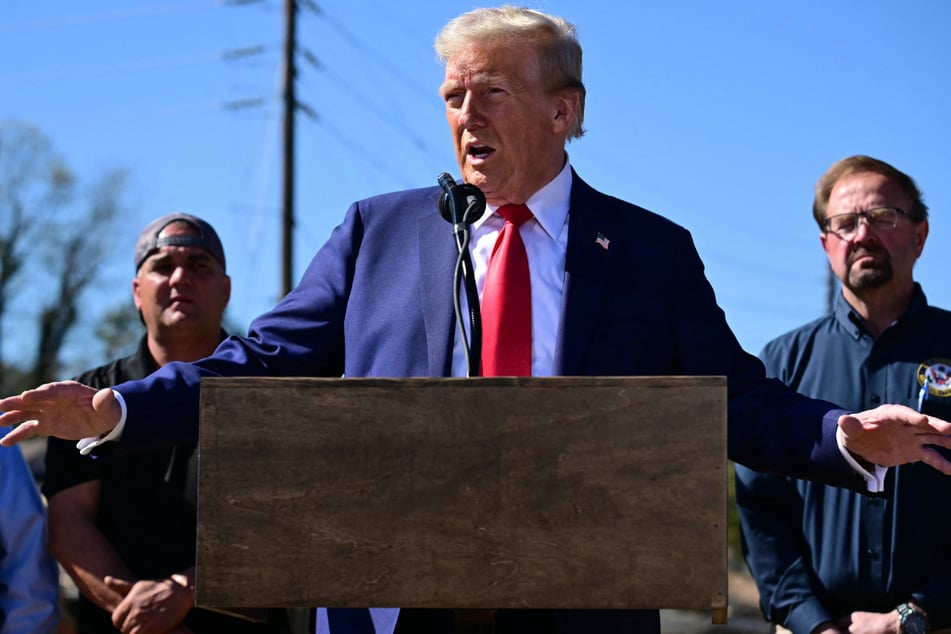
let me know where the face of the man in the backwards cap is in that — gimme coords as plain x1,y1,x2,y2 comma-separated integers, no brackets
132,223,231,336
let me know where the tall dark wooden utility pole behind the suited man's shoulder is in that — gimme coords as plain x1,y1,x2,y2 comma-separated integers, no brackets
281,0,297,297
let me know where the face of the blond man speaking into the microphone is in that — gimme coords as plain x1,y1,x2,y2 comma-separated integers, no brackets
439,43,578,205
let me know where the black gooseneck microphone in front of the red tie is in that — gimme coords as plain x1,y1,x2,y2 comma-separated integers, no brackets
436,172,485,377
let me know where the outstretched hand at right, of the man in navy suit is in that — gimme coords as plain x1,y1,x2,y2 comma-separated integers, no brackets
836,403,951,475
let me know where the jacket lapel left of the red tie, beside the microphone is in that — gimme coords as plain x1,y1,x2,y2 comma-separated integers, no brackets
417,212,457,376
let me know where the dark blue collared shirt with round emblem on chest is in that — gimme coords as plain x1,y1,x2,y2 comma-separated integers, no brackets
736,285,951,633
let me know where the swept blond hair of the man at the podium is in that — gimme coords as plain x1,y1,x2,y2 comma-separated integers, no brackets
435,5,585,139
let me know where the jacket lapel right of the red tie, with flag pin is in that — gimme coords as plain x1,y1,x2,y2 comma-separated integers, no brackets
554,172,617,376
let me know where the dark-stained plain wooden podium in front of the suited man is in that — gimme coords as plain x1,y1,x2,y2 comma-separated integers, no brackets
196,377,727,623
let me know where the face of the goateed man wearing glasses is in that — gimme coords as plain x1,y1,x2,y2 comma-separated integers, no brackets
820,172,928,296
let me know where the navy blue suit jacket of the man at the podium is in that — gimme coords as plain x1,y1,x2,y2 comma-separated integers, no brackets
117,168,864,489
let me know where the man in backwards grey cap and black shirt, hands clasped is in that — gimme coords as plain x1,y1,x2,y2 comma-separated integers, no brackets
43,213,283,633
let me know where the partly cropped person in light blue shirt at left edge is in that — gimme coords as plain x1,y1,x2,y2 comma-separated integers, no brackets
0,428,59,634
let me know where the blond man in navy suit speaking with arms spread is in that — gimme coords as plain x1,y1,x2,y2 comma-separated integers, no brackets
0,7,951,634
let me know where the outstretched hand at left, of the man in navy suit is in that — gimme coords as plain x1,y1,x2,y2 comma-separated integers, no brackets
0,381,122,447
